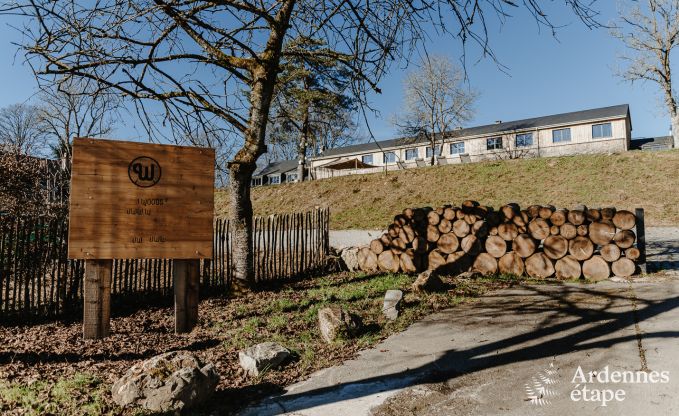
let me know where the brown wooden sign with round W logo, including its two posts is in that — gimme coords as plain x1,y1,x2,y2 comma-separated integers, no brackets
68,139,215,338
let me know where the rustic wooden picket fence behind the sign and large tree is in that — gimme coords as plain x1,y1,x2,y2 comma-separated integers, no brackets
0,208,330,320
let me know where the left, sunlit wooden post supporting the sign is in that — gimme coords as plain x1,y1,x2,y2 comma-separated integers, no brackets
83,260,113,339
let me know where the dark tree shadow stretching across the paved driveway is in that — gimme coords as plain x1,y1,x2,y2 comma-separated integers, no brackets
234,285,679,415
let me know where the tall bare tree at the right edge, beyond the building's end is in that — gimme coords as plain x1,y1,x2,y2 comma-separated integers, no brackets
612,0,679,148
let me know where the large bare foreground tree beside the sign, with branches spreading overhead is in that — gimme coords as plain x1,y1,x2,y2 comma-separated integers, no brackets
4,0,595,289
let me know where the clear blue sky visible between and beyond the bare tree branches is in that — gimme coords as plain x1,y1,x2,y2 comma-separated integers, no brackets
0,0,678,140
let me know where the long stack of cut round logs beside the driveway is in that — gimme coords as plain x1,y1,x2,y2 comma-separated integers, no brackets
358,200,641,280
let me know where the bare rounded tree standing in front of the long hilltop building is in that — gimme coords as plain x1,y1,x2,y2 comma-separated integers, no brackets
396,55,478,165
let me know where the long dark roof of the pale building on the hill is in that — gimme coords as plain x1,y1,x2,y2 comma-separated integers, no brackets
319,104,629,158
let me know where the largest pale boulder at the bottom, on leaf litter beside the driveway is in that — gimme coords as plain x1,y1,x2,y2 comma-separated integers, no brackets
111,351,219,412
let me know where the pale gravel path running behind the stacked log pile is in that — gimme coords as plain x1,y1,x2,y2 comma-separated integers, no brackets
330,227,679,276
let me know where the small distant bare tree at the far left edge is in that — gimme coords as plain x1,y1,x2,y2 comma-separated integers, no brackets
0,104,47,156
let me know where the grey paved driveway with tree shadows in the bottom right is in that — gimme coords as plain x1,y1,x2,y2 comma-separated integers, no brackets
244,277,679,416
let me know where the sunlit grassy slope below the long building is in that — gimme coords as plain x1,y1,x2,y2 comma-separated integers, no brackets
216,150,679,229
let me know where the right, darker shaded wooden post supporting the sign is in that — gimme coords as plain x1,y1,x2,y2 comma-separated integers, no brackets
172,260,200,334
